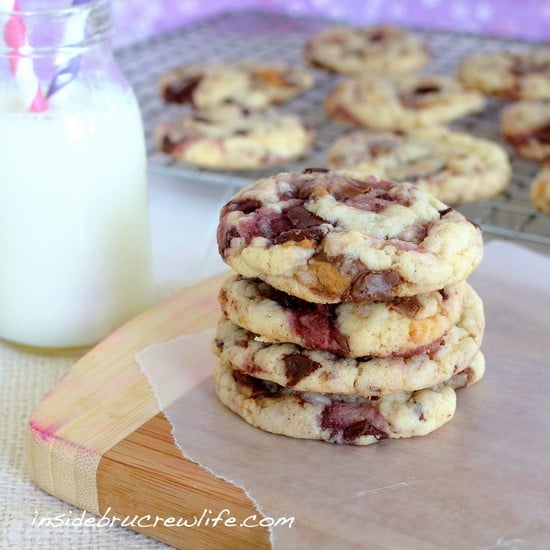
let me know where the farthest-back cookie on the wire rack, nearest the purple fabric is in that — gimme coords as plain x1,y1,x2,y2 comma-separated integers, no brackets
303,26,429,74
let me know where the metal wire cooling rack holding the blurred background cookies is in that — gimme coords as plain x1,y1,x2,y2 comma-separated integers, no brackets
116,12,550,249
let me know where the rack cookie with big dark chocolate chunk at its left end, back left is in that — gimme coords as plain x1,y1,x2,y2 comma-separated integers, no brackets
159,62,313,110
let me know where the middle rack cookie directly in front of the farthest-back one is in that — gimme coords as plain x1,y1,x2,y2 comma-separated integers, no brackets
325,73,485,130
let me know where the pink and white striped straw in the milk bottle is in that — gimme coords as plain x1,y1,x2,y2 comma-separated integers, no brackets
0,0,48,113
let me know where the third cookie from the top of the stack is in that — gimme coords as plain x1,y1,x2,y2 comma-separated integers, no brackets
213,286,485,396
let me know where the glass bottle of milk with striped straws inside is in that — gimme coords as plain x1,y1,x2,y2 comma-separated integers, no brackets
0,0,153,348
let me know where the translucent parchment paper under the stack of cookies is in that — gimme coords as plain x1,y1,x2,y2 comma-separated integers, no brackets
138,242,550,549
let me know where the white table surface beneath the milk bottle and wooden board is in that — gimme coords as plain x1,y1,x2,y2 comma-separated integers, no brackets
0,174,235,550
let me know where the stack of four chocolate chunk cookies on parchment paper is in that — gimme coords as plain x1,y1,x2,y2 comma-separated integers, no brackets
213,168,484,445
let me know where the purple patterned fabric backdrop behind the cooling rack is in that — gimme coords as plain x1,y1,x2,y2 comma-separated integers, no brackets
113,0,550,44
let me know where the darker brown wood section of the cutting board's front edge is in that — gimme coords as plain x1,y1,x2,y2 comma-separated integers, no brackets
97,413,270,550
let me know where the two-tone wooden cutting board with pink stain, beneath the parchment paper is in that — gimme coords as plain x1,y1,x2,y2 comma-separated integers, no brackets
29,274,270,548
